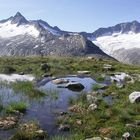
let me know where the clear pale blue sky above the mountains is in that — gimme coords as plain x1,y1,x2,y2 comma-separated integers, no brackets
0,0,140,32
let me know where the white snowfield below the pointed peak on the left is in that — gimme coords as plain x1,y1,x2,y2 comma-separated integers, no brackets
0,21,39,38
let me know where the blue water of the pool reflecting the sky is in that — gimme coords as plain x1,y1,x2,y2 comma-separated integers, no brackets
0,77,95,137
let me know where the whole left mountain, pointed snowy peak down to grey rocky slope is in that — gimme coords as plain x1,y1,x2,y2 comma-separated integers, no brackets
0,12,111,58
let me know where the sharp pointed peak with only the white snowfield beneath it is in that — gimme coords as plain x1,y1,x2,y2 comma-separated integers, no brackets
0,12,40,38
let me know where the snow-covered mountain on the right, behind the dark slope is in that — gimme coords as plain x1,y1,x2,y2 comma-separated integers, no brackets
80,21,140,65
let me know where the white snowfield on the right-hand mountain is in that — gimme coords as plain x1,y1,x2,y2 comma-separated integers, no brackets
93,32,140,56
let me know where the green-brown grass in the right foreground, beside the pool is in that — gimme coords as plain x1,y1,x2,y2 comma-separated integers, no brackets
61,81,140,140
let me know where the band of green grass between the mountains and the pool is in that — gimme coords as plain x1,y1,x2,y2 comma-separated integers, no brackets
0,57,140,77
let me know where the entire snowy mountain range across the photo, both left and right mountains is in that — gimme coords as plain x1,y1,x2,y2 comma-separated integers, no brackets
0,12,140,65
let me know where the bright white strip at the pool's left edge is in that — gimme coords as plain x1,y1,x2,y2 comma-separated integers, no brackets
0,74,35,82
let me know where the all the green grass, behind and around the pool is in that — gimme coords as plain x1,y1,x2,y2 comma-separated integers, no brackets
0,57,140,140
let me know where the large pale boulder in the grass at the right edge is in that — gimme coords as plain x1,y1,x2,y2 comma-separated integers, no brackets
129,91,140,103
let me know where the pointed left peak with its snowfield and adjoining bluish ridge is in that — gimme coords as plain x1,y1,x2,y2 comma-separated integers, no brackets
0,12,62,38
